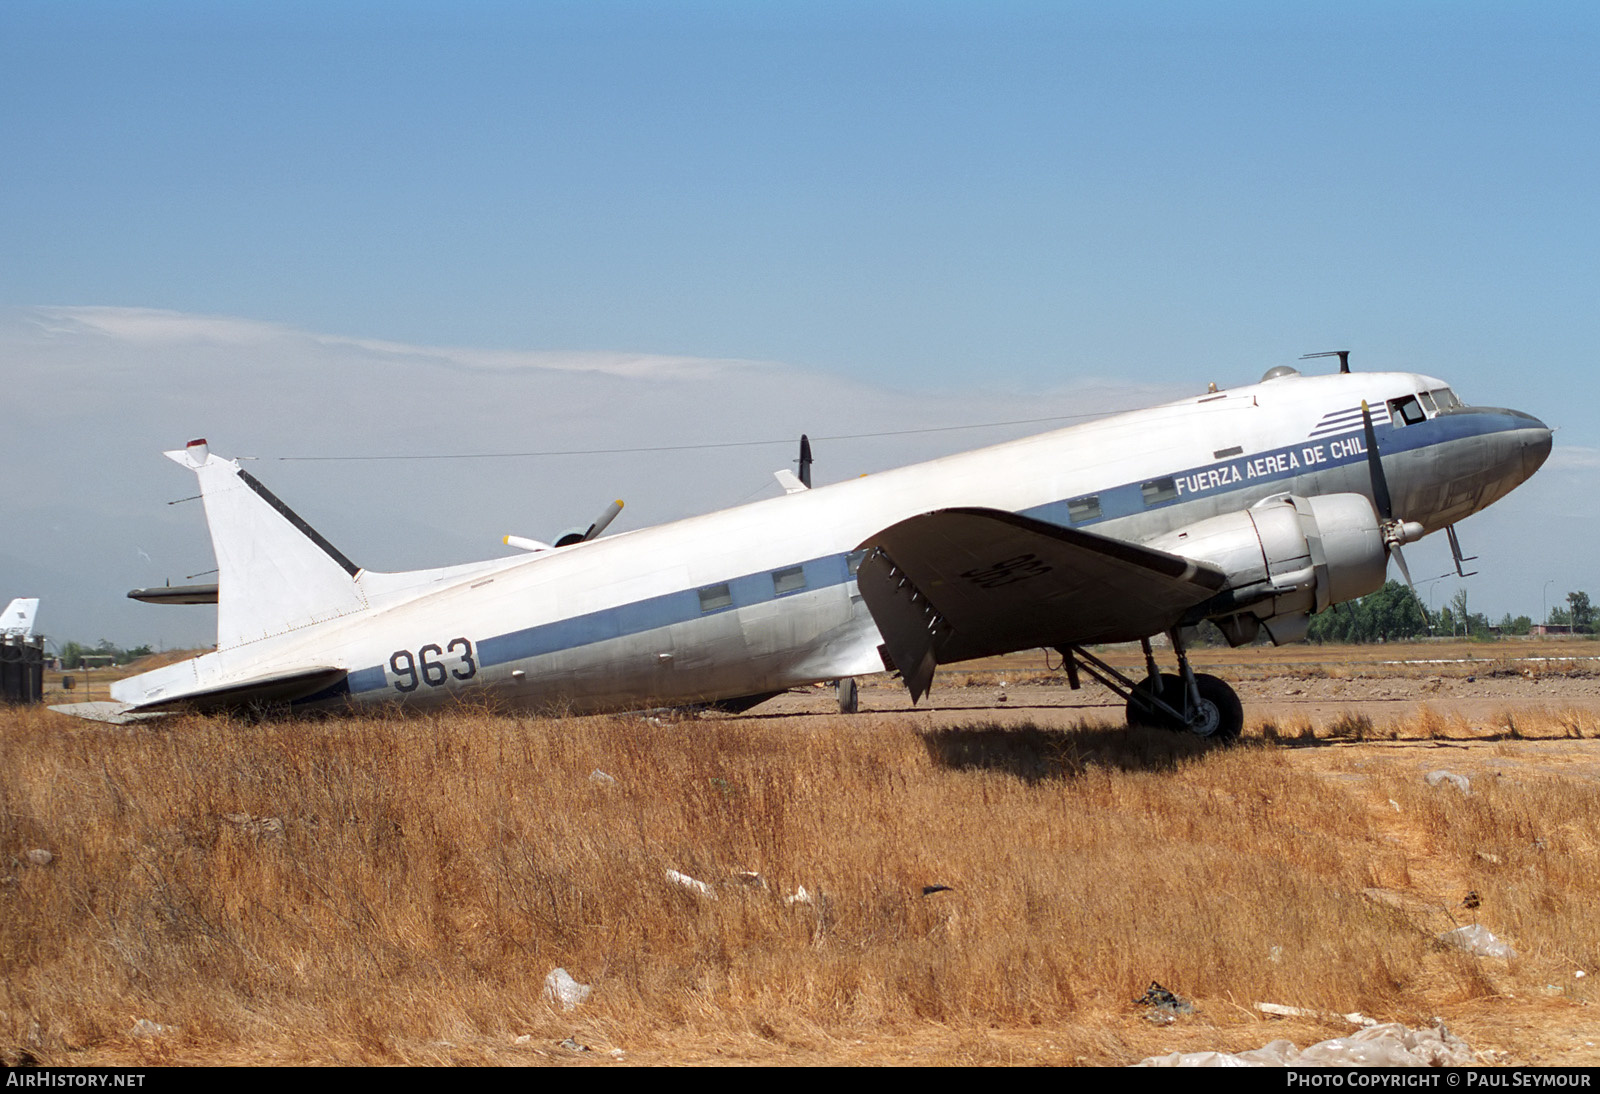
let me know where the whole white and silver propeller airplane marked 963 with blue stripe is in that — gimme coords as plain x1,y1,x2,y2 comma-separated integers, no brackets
65,353,1550,741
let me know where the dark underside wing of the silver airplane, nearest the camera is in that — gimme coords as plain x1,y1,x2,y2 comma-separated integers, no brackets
856,509,1227,702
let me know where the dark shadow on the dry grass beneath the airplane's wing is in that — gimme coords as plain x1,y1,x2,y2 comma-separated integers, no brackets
920,723,1219,782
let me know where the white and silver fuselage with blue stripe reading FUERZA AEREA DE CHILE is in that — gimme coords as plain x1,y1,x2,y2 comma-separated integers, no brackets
114,373,1550,712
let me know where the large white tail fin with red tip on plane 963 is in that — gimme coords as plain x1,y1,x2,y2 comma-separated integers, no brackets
165,440,366,649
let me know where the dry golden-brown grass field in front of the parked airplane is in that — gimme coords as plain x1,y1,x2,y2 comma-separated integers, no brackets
0,697,1600,1064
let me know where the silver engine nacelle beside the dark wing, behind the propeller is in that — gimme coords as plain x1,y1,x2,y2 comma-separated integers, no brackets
1146,494,1389,646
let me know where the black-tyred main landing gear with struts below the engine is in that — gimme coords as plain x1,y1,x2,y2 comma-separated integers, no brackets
1061,630,1245,744
